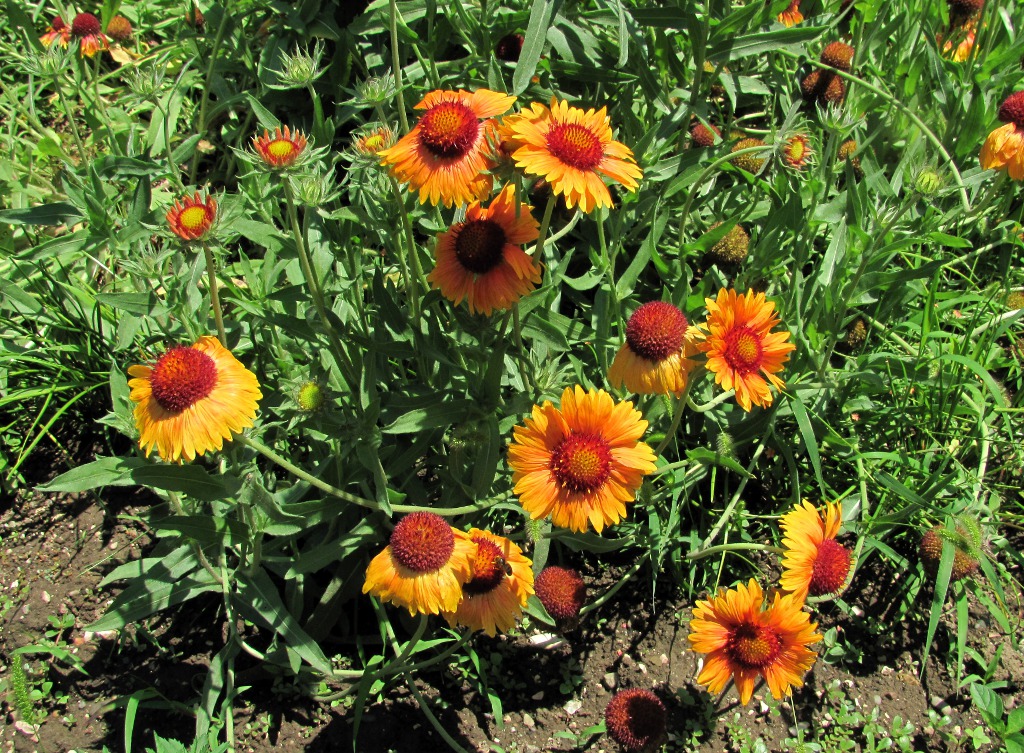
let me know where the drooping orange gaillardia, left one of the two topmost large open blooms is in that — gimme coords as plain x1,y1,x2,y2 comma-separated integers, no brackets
380,89,515,207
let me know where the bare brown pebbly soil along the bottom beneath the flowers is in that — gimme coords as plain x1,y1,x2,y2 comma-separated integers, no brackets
0,463,1024,753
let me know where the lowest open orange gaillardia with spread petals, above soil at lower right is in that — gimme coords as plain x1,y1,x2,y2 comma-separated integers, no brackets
687,578,821,705
